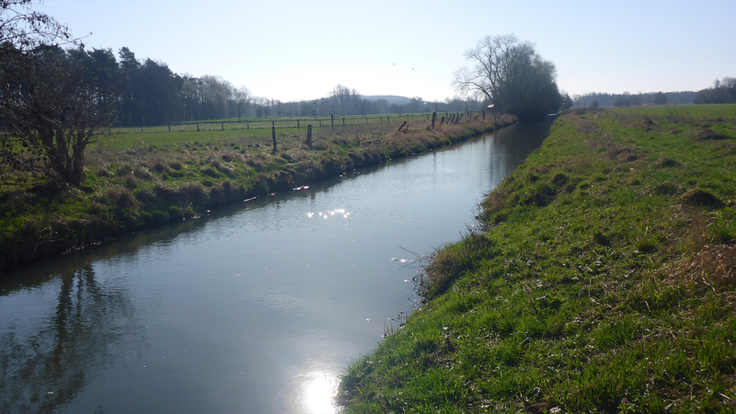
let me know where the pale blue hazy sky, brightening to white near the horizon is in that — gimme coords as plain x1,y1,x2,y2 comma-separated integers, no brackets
44,0,736,102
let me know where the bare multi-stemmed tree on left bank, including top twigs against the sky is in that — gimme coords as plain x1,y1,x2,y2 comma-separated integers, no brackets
0,0,112,183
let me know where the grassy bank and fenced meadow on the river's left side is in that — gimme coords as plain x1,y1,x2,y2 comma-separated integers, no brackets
0,115,513,274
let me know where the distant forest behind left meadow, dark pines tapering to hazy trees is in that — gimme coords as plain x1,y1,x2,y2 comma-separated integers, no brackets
50,47,482,126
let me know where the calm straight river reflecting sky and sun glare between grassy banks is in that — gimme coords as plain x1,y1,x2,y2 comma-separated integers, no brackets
0,119,550,414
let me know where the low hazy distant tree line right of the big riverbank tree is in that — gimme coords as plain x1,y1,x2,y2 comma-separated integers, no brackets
573,92,695,108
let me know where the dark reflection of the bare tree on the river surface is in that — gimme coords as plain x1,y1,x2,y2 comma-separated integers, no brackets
0,265,144,413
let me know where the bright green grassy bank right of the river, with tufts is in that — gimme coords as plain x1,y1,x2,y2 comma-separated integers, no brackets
338,105,736,413
